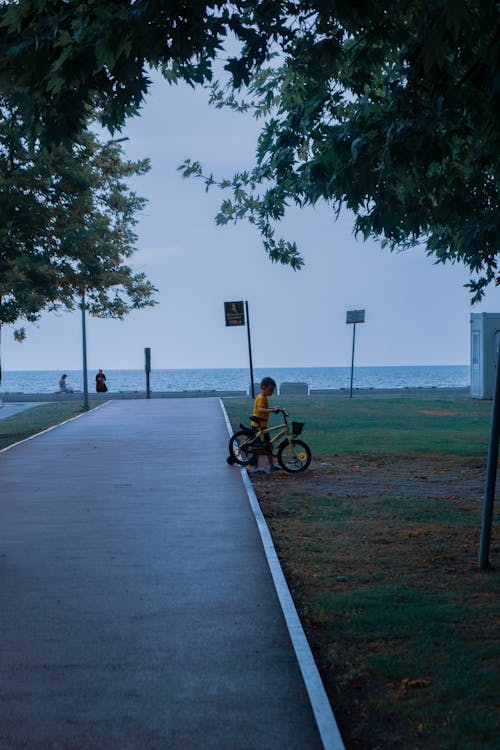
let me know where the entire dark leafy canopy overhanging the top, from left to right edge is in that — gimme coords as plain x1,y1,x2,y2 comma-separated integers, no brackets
0,0,500,299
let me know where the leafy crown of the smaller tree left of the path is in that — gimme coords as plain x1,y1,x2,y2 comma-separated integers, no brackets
0,92,155,334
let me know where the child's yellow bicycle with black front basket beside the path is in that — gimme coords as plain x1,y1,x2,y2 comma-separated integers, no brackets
227,409,312,474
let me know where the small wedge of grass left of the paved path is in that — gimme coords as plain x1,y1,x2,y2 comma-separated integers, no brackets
0,399,102,450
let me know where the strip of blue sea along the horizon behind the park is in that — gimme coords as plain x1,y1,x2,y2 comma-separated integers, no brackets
0,365,470,394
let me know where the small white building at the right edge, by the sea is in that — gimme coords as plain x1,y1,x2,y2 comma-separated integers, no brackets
470,313,500,399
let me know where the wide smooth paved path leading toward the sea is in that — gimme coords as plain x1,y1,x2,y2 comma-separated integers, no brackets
0,399,322,750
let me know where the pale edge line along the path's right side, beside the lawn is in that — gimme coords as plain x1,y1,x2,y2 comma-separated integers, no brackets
219,398,345,750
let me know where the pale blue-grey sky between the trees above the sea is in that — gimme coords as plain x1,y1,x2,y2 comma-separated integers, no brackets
2,72,500,370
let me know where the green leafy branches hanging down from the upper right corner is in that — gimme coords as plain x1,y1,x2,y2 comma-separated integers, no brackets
181,0,500,301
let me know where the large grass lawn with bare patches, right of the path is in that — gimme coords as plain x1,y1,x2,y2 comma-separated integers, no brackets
225,393,500,750
